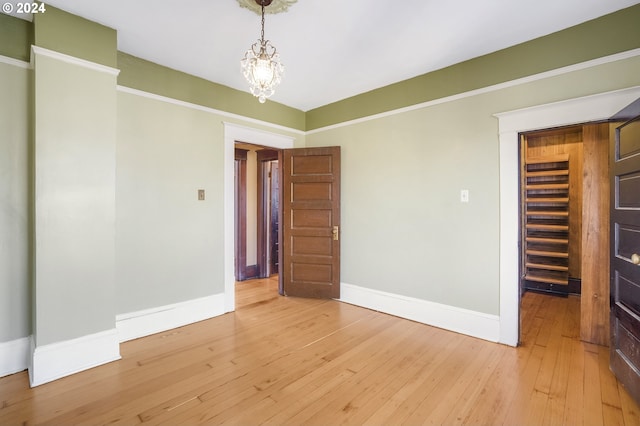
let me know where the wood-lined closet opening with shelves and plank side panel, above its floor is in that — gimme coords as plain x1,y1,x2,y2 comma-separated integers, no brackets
520,122,610,345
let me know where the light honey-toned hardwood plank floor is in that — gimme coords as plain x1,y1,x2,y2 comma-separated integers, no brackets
0,279,640,425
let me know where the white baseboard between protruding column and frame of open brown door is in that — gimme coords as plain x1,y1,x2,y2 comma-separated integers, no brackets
116,293,225,342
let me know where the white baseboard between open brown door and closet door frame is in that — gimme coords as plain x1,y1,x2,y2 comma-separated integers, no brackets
340,283,500,342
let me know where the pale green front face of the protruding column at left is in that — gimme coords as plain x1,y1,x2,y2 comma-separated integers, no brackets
32,54,116,346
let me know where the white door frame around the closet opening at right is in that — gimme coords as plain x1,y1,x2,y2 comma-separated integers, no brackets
495,86,640,346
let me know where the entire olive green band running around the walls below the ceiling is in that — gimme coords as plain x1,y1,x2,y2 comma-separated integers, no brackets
5,4,640,131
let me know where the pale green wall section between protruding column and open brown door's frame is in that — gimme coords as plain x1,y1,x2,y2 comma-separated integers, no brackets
116,92,224,313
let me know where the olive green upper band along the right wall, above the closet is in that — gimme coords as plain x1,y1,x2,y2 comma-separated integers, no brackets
306,5,640,130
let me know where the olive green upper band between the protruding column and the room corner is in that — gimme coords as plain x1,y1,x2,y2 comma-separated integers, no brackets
118,52,305,130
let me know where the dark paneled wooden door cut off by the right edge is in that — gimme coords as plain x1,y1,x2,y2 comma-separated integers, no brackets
610,112,640,403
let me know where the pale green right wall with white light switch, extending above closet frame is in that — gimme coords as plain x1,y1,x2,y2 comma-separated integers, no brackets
307,53,640,315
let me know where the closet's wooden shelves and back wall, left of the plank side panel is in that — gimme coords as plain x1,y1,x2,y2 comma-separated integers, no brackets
521,126,583,294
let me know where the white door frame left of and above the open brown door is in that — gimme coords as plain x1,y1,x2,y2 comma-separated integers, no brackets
223,122,295,312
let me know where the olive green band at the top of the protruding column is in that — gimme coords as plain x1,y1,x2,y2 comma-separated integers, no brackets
33,4,118,68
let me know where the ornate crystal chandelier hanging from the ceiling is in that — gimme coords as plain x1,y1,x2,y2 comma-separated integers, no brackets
240,0,284,103
